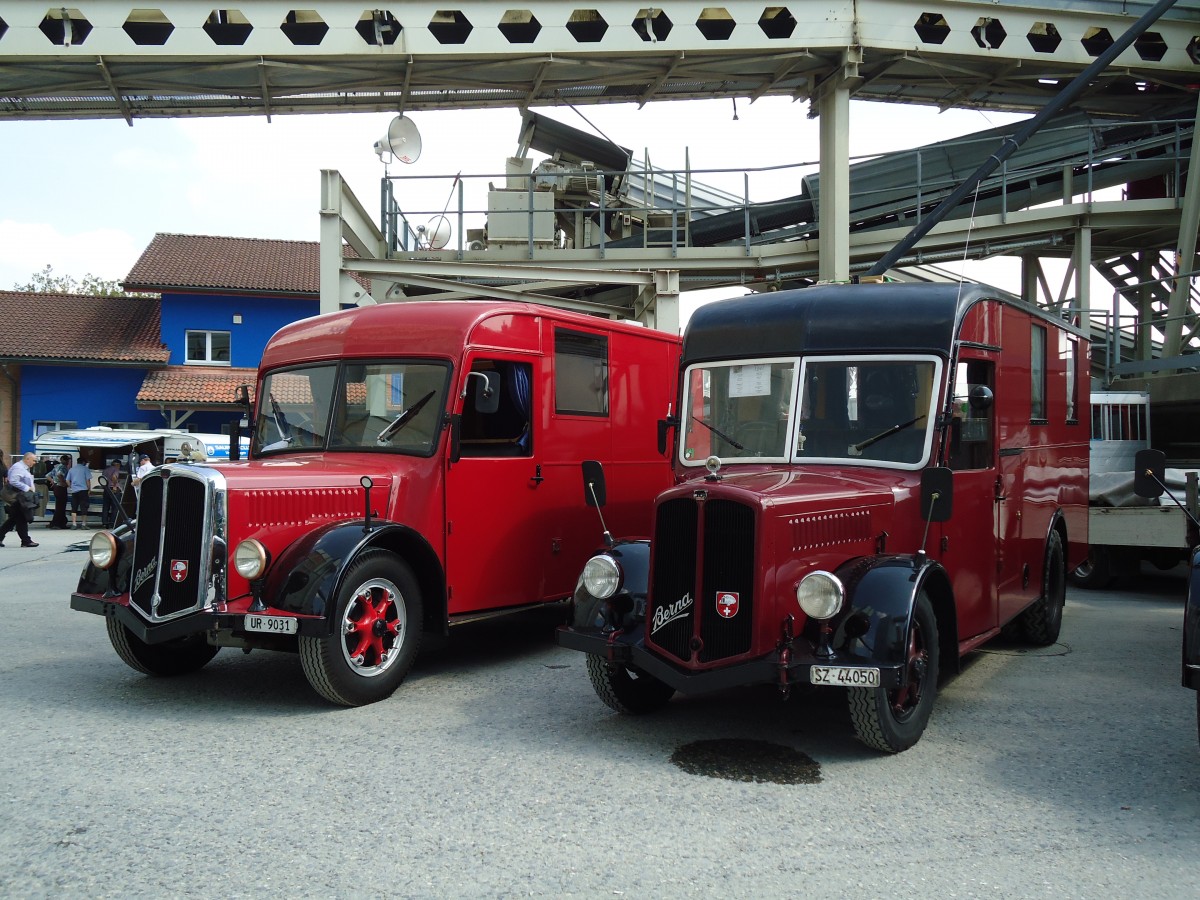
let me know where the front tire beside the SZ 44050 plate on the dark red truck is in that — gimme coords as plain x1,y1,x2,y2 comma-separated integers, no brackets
848,590,938,754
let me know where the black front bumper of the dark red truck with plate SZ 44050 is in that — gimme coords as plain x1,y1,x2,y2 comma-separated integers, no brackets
556,625,905,694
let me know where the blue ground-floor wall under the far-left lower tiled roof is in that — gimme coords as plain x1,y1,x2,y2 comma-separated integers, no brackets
20,362,152,451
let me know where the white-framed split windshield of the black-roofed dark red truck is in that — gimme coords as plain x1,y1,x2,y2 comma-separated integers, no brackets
680,355,942,468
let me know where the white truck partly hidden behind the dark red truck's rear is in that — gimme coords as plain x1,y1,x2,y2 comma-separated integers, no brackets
1070,390,1200,589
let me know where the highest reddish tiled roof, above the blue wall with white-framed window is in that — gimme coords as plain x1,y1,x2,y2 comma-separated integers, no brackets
124,233,336,299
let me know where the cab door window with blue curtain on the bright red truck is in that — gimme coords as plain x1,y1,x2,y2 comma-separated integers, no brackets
460,359,533,457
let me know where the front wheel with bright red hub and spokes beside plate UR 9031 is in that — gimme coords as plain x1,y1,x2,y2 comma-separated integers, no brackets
300,550,422,707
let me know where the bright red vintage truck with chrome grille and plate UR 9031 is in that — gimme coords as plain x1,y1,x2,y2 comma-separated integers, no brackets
71,301,679,706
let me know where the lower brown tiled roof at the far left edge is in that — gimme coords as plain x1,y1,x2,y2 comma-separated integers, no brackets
0,290,170,366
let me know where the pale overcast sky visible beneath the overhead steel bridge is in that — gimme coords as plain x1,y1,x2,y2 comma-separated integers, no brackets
0,98,1032,296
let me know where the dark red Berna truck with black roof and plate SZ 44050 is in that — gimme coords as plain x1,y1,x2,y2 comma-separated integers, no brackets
558,284,1090,751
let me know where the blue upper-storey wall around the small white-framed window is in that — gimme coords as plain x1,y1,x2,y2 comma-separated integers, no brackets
162,294,320,368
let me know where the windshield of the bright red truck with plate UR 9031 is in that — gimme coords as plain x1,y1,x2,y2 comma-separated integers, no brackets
254,362,449,456
